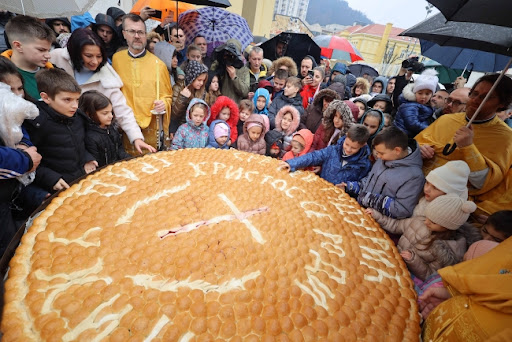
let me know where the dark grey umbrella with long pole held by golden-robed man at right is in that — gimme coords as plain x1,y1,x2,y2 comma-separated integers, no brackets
400,13,512,155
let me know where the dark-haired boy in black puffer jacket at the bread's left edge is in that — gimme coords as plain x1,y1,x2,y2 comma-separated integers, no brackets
24,69,98,195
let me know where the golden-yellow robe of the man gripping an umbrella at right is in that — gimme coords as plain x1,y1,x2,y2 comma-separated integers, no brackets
415,113,512,214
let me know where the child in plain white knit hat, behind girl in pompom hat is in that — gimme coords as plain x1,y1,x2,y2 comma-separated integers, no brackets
412,160,470,217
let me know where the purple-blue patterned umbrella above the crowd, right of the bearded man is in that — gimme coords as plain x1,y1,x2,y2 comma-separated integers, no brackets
178,7,253,51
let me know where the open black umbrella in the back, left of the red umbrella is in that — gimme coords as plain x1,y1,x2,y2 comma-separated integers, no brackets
260,32,321,67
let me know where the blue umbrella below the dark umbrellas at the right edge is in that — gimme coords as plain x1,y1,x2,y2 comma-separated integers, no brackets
420,39,510,72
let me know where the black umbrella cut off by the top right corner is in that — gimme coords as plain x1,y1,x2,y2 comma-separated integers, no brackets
427,0,512,27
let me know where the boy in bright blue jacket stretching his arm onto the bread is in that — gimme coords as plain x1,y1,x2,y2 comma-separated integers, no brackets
281,125,371,184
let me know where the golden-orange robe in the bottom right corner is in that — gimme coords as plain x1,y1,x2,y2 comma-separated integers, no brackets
423,237,512,342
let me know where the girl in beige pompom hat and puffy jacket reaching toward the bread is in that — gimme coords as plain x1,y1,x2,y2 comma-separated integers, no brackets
366,194,480,281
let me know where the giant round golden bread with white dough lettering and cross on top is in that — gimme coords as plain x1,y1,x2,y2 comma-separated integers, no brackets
1,149,420,342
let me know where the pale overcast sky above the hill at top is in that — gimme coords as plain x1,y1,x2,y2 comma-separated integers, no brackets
346,0,436,29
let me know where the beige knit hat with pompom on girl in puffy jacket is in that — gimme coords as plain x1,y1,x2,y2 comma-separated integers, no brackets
425,194,476,230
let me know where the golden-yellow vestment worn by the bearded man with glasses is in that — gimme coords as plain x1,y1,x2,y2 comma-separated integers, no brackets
112,50,172,135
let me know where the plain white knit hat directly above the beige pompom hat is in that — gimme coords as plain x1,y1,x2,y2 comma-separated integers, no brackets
426,160,470,200
